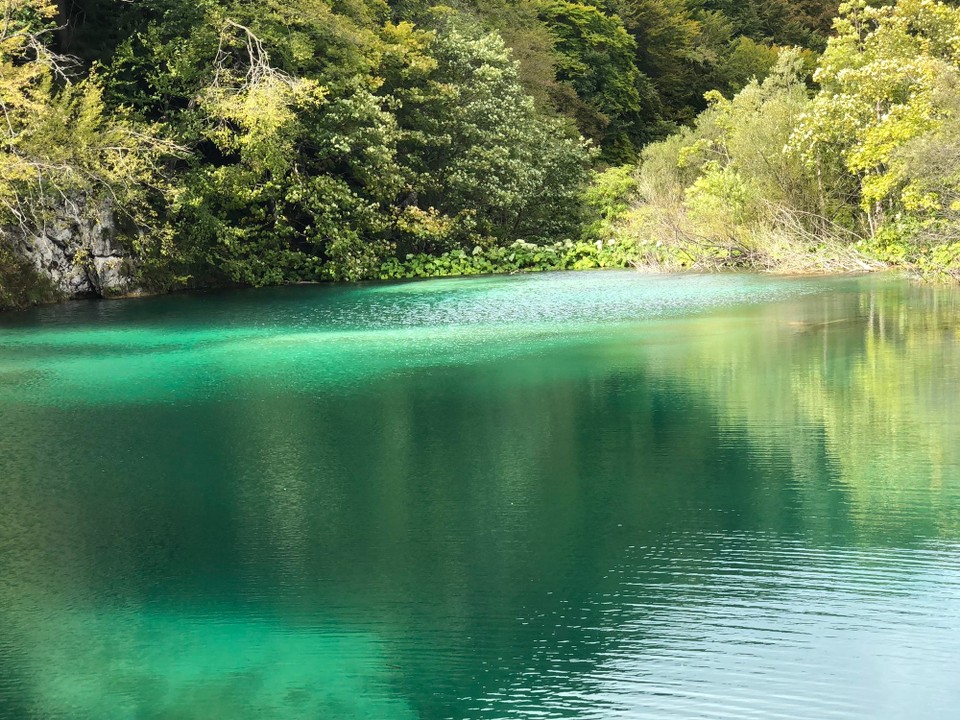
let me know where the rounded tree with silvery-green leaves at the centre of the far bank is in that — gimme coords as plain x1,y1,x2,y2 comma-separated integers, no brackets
383,11,589,249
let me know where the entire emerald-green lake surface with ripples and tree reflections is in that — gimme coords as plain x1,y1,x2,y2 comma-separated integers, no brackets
0,273,960,720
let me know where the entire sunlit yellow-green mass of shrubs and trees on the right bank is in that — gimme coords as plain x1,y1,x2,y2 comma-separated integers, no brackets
632,0,960,275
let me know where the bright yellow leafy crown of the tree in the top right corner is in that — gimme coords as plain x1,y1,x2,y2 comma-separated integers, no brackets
790,0,960,221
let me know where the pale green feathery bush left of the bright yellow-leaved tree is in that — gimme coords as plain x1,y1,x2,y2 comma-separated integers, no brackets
629,50,840,267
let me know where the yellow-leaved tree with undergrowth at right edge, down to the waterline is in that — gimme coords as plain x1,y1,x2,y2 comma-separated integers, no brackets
790,0,960,276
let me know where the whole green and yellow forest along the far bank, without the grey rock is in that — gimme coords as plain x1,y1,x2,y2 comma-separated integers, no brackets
0,0,960,307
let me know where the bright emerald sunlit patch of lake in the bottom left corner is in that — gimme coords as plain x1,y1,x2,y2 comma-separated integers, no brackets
8,608,416,720
